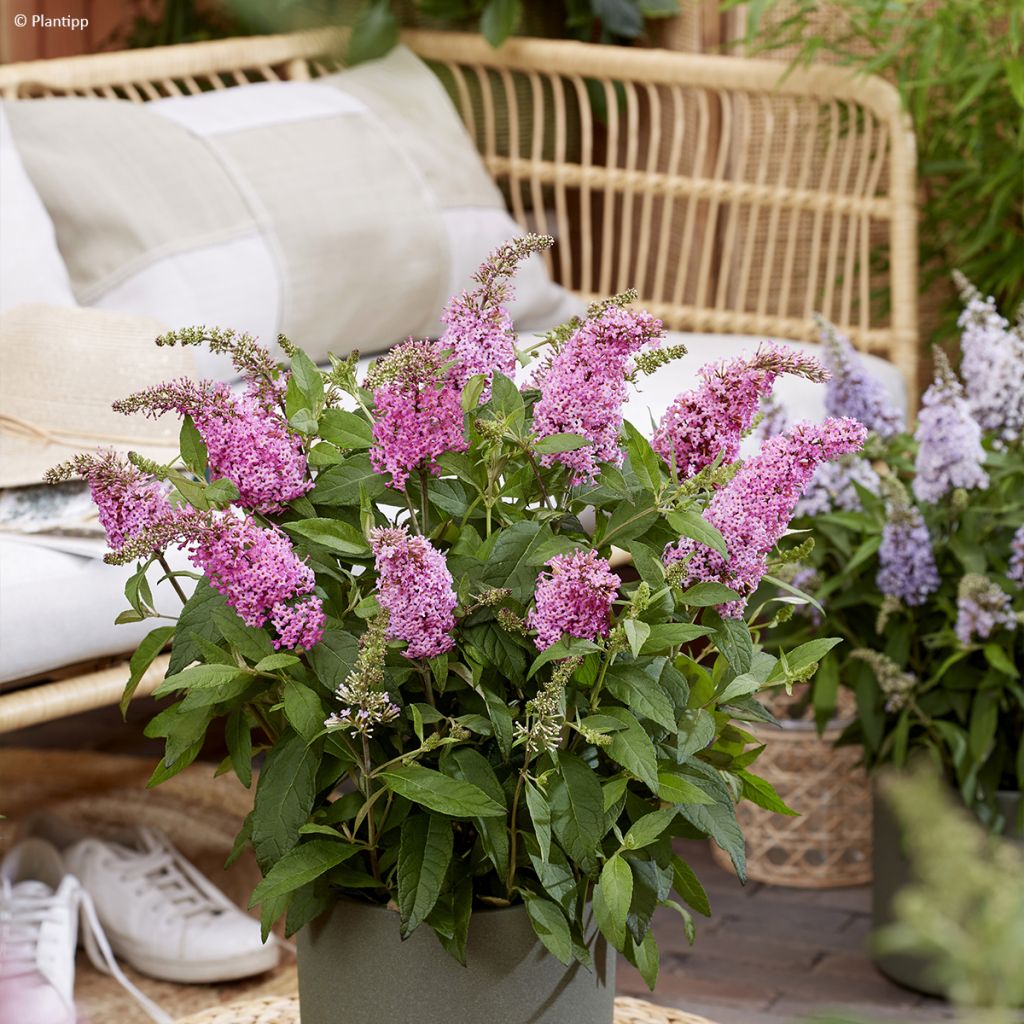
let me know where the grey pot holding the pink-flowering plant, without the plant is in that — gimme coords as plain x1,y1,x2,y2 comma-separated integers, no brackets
298,900,615,1024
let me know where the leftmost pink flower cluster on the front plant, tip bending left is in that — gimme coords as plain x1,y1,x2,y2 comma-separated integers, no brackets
46,451,171,551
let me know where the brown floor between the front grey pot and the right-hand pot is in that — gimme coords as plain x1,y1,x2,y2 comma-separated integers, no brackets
618,843,954,1024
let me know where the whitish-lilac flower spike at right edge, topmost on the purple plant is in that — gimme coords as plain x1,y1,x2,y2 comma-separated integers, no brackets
953,271,1024,441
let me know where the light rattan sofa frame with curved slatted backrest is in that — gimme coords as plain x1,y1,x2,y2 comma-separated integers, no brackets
0,25,918,732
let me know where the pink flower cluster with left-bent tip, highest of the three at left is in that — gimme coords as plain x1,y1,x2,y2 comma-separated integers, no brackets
114,379,312,514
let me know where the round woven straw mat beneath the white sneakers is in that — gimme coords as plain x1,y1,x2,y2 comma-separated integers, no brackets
0,749,296,1024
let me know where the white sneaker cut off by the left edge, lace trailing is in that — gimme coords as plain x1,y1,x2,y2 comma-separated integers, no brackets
0,839,171,1024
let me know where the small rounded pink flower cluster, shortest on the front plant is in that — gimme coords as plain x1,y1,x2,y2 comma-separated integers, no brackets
526,551,622,650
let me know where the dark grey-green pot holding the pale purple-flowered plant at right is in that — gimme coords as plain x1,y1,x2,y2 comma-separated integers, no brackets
871,788,1024,996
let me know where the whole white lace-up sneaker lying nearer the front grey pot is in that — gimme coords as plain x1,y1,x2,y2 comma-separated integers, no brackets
65,826,281,984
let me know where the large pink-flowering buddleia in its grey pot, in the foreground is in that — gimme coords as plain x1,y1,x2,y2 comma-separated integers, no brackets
51,236,865,1024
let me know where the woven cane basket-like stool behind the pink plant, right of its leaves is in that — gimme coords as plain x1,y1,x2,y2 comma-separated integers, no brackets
712,708,871,889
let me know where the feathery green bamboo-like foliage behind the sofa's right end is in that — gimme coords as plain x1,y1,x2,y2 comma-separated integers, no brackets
724,0,1024,333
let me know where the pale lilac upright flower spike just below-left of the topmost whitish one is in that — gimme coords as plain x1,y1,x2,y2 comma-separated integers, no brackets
913,350,988,504
